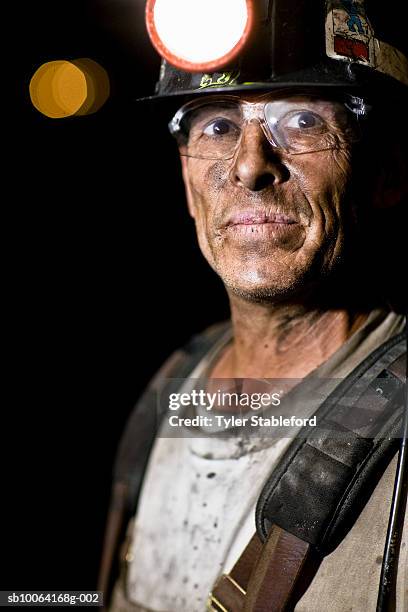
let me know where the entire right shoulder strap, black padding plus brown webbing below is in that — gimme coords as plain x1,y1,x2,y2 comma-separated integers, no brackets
207,334,406,612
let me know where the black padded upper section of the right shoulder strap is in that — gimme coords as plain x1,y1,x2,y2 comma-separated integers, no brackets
256,333,406,555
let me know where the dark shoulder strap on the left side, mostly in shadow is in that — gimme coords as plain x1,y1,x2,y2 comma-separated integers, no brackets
98,321,231,605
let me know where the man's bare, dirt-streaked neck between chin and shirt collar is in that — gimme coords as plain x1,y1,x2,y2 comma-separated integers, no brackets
212,296,367,378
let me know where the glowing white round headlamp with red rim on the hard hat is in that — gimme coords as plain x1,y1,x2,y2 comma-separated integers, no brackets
146,0,253,72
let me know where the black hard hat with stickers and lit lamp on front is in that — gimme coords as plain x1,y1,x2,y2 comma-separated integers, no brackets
144,0,408,100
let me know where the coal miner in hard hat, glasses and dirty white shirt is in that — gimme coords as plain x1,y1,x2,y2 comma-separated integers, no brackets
101,0,408,612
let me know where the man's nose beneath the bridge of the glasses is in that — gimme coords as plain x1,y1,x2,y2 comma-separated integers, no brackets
230,120,289,191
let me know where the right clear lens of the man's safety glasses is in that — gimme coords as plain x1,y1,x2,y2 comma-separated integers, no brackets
264,98,357,154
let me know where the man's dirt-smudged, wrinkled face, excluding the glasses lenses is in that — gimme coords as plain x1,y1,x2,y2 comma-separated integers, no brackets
181,95,353,301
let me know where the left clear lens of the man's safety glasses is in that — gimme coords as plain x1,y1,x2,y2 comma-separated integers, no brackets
173,101,242,159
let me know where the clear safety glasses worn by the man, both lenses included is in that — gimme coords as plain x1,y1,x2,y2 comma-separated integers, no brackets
169,94,365,159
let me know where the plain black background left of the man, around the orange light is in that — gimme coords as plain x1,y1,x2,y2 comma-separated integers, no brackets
4,0,228,590
